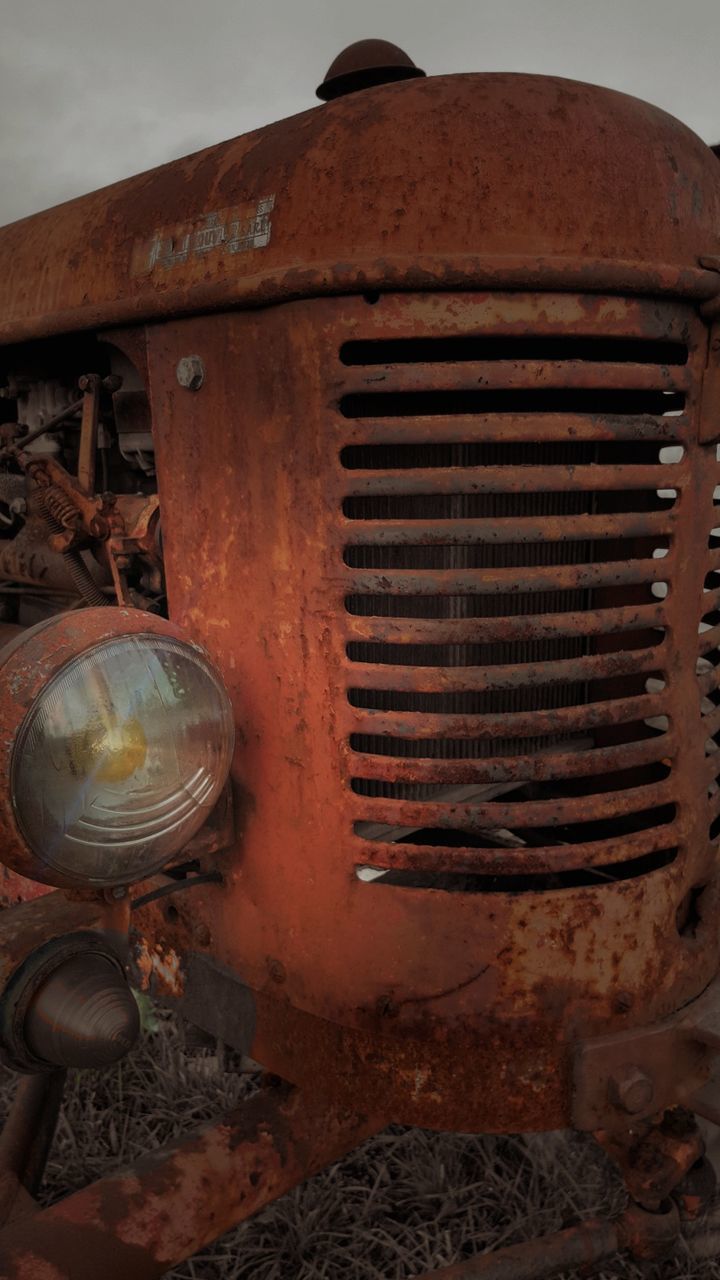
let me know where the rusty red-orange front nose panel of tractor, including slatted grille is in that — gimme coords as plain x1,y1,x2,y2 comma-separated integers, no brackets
131,293,719,1129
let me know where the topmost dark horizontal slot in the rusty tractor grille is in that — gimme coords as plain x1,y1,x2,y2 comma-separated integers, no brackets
340,334,688,365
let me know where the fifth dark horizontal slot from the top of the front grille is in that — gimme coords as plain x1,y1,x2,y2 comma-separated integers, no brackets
342,536,670,570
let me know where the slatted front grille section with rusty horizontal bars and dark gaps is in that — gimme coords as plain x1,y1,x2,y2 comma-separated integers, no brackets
336,298,696,892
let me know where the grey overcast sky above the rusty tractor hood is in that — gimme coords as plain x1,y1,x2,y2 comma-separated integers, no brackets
0,0,720,224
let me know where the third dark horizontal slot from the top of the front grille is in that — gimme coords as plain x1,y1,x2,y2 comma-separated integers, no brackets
340,440,685,471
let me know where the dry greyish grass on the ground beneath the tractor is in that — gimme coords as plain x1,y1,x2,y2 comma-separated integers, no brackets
0,1021,720,1280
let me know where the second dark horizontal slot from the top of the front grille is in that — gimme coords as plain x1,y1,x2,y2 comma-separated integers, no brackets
340,387,685,417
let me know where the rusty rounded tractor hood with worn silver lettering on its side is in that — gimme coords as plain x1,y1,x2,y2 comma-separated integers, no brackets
0,74,720,340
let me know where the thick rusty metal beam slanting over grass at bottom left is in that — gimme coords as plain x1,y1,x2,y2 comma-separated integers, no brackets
0,1087,382,1280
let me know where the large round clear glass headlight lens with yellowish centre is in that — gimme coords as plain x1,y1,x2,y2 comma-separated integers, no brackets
10,634,233,886
